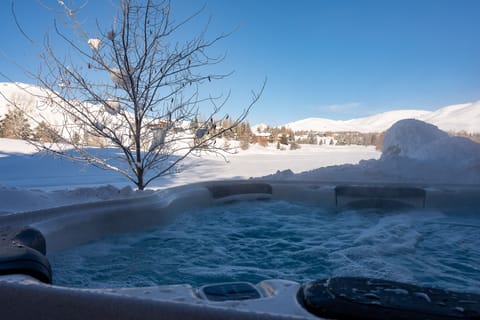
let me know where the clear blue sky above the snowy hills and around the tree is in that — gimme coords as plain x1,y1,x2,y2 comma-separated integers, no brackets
0,0,480,125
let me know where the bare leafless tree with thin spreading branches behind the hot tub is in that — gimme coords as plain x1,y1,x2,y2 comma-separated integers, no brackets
6,0,265,190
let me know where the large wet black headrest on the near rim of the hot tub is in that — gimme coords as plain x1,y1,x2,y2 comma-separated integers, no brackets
297,277,480,320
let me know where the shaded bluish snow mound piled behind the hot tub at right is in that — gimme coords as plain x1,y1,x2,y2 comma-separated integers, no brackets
262,119,480,185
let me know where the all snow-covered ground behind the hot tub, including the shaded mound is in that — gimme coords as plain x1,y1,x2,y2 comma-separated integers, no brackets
0,120,480,214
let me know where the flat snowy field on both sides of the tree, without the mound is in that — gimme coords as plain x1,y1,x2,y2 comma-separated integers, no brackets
0,139,380,214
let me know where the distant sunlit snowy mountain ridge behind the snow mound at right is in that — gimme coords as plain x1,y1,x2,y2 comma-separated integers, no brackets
285,101,480,133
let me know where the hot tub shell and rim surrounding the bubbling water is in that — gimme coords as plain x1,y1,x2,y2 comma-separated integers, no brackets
0,180,480,319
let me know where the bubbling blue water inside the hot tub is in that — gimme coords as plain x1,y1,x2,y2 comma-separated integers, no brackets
50,200,480,292
